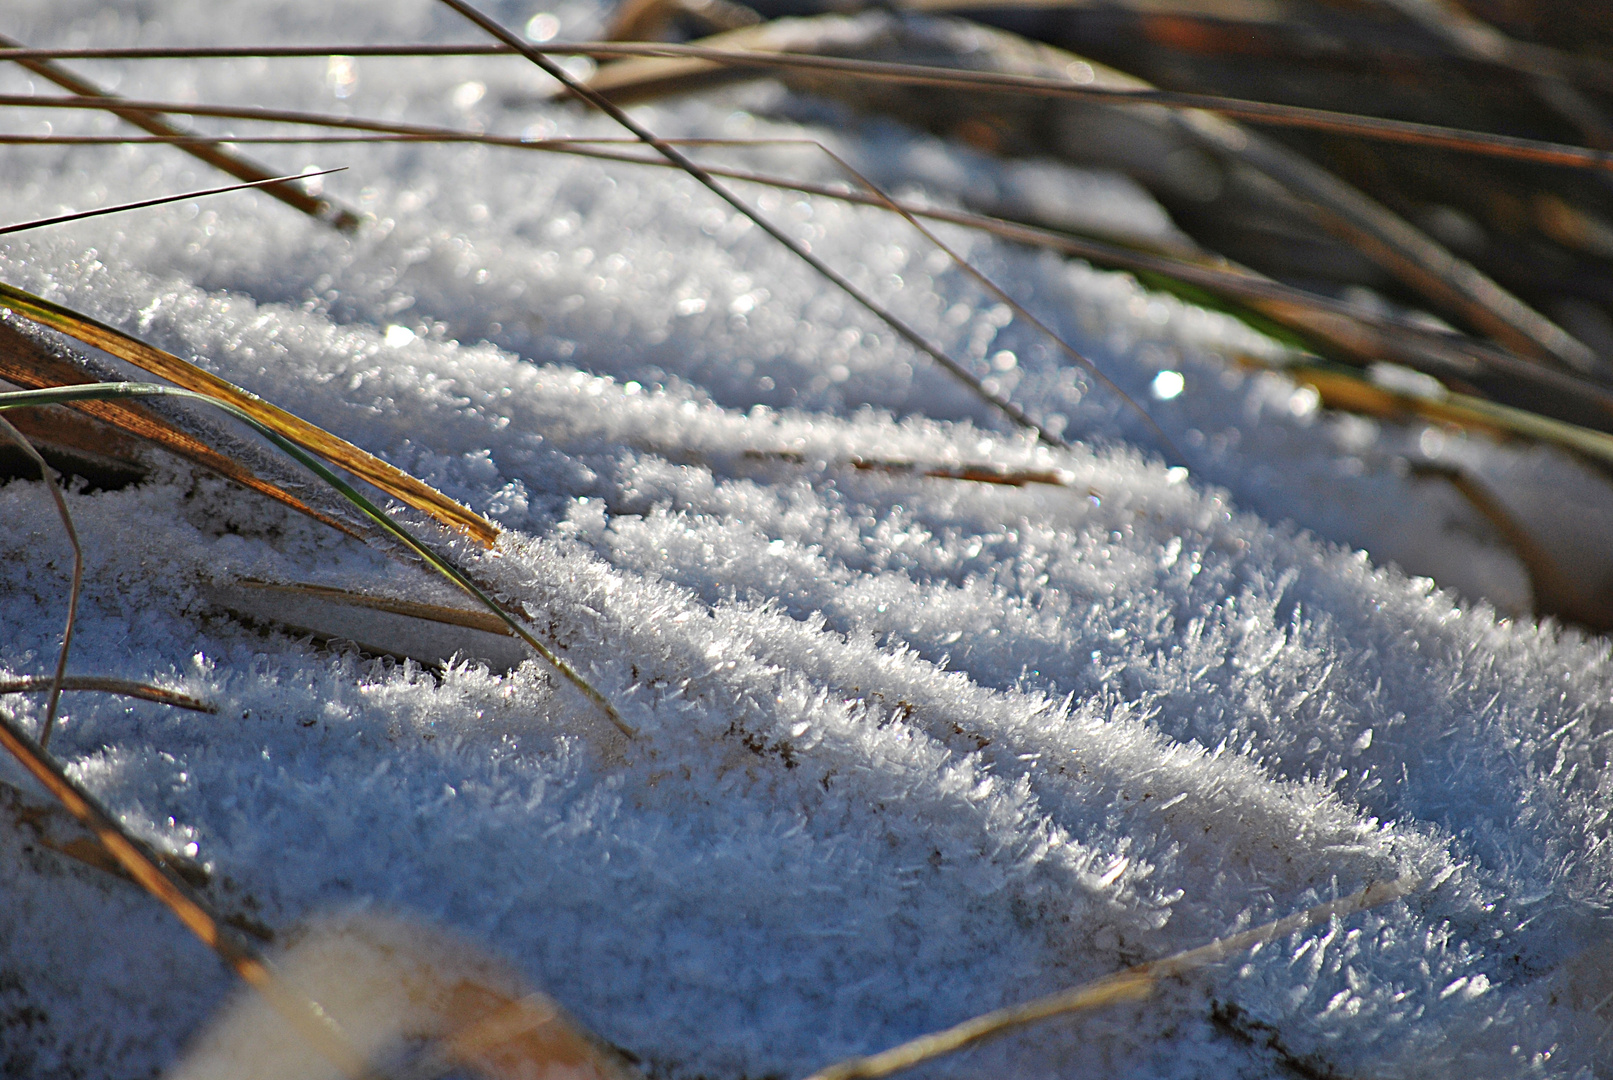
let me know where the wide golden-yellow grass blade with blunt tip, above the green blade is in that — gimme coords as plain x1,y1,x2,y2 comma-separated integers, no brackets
0,282,498,546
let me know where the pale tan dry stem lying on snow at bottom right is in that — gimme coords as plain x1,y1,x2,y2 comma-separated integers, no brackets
807,879,1421,1080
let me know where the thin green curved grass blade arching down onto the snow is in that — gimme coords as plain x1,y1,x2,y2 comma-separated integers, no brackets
0,382,637,738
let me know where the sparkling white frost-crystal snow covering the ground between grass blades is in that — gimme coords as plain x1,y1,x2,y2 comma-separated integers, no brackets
0,0,1613,1080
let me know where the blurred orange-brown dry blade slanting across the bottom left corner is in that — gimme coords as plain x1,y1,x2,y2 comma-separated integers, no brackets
0,709,374,1080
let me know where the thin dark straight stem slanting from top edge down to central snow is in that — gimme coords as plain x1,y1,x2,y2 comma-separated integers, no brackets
440,0,1068,448
